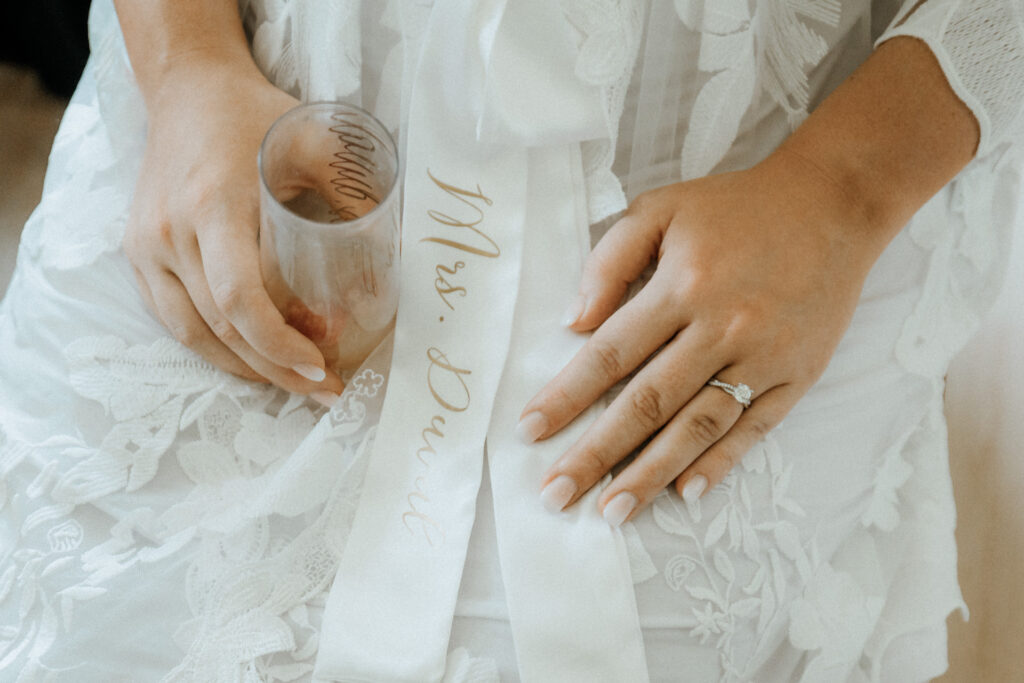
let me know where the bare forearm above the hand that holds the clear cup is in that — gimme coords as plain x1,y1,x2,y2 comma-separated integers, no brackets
115,0,256,105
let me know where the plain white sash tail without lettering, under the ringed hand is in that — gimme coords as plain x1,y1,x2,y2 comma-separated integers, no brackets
487,145,647,683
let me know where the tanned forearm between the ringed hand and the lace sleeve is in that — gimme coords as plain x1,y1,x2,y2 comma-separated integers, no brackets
769,37,979,261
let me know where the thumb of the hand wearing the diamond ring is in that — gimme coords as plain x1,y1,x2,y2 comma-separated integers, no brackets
565,209,663,332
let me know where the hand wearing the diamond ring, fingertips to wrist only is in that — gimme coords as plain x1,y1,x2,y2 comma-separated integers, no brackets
518,152,884,525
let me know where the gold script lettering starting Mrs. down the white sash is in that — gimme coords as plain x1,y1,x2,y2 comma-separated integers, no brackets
401,169,502,547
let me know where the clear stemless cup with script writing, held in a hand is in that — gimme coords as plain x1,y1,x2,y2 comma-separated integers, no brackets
259,102,400,372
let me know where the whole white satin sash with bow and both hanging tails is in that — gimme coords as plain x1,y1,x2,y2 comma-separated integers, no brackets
315,0,646,683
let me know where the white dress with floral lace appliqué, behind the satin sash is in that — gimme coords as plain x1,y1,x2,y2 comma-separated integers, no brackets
0,0,1024,683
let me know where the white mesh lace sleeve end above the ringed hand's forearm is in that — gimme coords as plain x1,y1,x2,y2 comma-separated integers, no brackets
876,0,1024,158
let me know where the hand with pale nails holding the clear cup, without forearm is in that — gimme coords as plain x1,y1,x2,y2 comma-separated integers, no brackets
124,55,343,404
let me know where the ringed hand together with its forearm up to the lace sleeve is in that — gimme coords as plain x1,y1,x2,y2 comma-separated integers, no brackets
518,37,980,524
